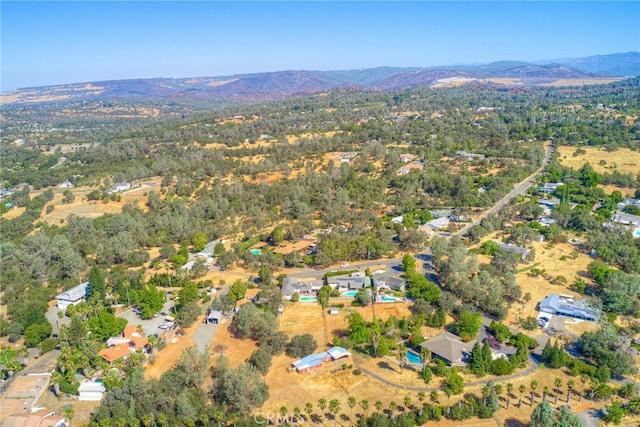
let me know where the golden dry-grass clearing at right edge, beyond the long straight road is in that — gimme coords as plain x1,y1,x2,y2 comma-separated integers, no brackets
556,146,640,175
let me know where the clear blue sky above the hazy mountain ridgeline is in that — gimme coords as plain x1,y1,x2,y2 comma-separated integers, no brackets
0,0,640,92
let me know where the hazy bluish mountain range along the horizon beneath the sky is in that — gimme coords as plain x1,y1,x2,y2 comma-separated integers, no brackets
0,52,640,105
